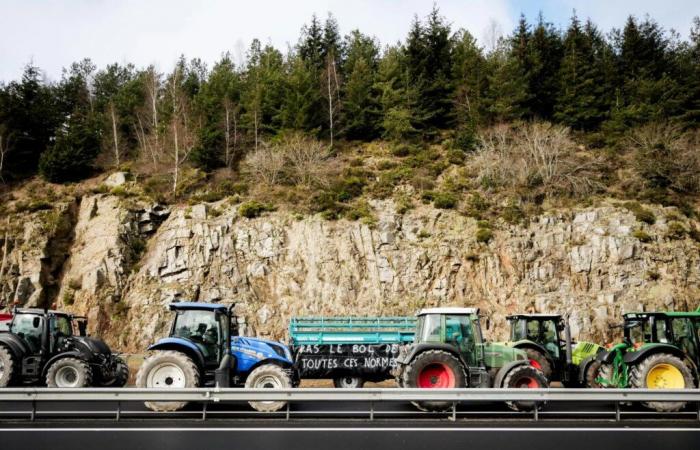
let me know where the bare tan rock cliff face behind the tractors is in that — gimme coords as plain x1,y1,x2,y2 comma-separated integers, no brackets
1,195,700,351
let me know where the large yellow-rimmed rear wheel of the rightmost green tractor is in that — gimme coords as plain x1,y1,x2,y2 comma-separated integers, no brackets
630,353,695,412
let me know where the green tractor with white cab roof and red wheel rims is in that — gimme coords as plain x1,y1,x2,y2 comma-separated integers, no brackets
395,308,547,411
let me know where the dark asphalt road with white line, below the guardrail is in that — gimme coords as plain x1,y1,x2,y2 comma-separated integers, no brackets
0,402,700,450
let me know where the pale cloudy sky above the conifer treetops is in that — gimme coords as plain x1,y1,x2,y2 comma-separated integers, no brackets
0,0,700,81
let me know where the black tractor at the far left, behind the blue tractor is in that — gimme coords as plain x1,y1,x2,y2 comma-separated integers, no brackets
0,308,129,388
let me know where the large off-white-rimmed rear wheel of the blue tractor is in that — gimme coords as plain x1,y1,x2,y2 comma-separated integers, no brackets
136,350,199,411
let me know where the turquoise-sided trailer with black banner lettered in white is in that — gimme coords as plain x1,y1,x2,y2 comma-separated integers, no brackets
289,317,416,388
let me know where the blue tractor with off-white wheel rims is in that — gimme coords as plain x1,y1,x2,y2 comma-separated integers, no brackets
136,302,297,411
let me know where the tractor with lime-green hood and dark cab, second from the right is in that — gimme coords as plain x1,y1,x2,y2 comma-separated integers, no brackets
505,314,605,387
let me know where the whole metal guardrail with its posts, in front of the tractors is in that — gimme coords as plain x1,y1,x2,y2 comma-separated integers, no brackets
0,388,700,421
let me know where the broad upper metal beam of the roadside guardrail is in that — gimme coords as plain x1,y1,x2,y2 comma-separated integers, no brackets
0,388,700,403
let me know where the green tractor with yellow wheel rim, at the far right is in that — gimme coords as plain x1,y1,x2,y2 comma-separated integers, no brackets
597,311,700,411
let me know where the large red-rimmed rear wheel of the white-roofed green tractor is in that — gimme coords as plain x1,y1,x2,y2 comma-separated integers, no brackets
402,350,467,411
